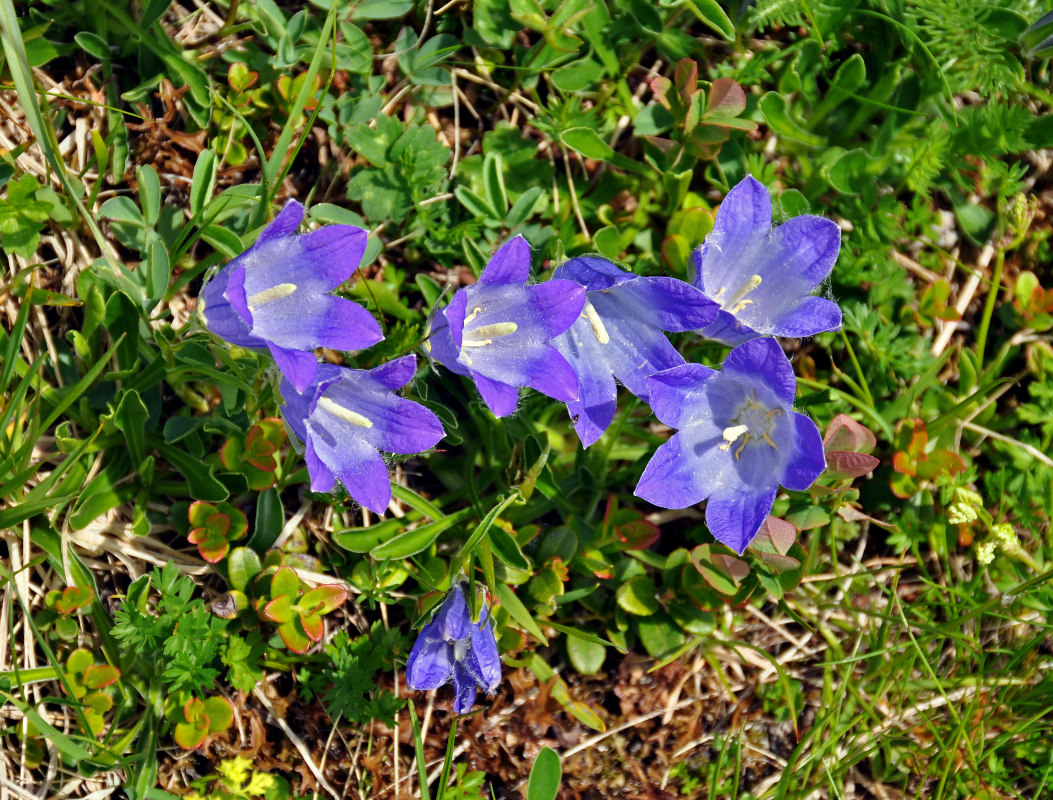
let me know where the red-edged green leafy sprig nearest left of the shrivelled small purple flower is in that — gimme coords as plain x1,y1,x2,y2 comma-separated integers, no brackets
256,566,347,653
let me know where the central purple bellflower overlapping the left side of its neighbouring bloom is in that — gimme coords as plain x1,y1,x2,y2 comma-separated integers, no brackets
424,236,585,417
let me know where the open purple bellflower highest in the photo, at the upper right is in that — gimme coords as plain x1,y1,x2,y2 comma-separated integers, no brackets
693,175,841,345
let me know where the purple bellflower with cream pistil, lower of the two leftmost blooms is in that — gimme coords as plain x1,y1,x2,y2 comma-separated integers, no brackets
281,356,445,514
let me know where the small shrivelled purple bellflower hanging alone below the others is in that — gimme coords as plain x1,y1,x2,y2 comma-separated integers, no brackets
405,583,501,714
